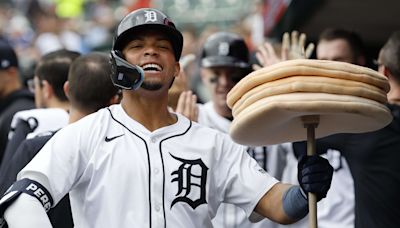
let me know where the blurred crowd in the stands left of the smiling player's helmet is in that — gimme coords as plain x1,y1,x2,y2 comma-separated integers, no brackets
0,0,155,81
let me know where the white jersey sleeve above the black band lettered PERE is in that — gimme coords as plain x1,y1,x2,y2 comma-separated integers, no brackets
17,121,90,206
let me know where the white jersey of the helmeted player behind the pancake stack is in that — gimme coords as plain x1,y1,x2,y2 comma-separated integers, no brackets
198,102,286,228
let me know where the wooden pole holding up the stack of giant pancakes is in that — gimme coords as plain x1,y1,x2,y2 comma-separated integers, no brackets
301,115,319,228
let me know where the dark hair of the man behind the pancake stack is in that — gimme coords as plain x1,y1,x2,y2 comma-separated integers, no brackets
319,28,365,60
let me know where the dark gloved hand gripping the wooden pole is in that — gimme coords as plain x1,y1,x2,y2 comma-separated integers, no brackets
297,155,333,201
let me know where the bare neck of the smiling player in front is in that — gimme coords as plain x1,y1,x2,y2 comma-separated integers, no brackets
121,95,177,131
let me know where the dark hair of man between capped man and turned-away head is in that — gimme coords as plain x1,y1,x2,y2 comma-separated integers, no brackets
35,49,81,101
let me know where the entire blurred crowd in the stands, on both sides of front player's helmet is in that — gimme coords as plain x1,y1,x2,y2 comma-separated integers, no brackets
0,0,264,91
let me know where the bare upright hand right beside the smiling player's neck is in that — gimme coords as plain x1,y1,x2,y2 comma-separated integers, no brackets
175,90,199,122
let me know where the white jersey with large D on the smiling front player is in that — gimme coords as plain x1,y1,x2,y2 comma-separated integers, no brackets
18,105,277,228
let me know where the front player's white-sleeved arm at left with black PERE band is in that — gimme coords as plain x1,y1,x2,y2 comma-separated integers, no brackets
0,124,88,228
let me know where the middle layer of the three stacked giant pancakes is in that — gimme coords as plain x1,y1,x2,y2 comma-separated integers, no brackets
232,76,387,116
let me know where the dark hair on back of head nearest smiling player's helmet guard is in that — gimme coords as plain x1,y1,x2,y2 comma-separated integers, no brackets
68,52,118,113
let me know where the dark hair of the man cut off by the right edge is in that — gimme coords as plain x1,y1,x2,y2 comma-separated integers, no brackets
380,31,400,82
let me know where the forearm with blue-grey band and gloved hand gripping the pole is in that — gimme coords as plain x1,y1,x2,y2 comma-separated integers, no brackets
255,155,333,224
